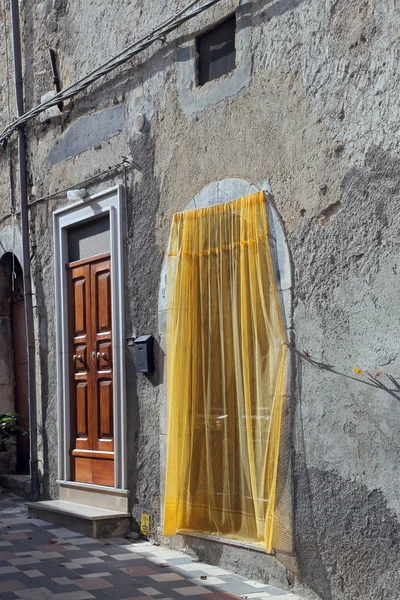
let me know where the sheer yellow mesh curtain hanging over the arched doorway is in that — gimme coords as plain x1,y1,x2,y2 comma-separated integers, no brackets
164,192,286,552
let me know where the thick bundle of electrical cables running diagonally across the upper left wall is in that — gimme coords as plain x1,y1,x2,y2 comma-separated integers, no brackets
0,0,225,146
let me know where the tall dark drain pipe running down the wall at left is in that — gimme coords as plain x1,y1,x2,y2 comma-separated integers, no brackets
10,0,39,502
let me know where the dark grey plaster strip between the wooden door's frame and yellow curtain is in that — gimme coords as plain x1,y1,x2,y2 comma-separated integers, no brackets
125,116,163,523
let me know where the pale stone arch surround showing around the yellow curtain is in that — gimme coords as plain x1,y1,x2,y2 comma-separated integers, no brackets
158,177,297,571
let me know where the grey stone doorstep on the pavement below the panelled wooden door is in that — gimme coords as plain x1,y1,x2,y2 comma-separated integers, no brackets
26,500,131,539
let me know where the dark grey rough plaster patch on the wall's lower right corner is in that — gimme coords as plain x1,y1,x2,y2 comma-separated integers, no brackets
294,365,400,600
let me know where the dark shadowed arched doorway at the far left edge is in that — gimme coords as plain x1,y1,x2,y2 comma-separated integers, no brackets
0,252,29,474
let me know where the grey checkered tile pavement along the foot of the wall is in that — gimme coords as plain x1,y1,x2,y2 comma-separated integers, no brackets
0,494,298,600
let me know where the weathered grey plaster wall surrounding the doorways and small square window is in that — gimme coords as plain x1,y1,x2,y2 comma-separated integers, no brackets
0,0,400,600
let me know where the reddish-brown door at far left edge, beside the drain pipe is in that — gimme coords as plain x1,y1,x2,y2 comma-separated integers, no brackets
11,299,29,473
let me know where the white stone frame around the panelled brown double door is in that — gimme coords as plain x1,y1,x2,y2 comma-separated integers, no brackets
53,186,127,490
